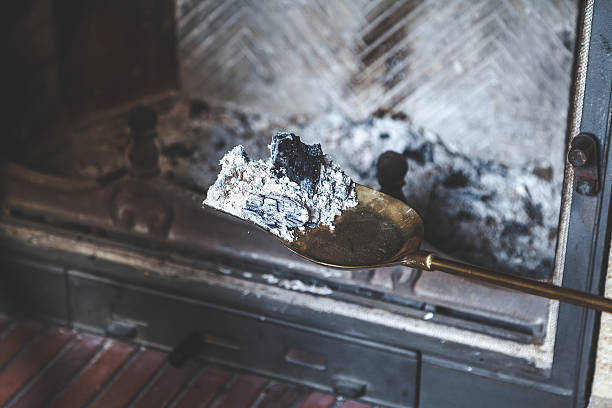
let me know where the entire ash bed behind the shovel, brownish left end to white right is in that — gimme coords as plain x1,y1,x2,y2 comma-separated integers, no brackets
159,105,562,277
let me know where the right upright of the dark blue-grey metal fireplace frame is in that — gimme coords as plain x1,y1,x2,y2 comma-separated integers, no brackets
551,1,612,406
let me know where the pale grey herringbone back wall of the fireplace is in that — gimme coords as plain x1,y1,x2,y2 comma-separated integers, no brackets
177,0,578,174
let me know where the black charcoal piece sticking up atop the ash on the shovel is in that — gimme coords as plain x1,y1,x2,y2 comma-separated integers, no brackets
270,133,323,197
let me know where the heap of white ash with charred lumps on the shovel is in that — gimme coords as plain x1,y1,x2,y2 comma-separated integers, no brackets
203,132,357,242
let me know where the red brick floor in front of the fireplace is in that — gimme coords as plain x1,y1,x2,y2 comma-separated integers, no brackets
0,314,369,408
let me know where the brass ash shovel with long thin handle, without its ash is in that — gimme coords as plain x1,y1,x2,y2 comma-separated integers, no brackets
280,184,612,312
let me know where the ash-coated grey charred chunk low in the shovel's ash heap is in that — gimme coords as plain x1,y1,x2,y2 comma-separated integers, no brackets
244,194,309,228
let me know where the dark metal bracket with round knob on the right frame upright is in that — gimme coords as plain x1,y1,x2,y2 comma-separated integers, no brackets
567,133,600,196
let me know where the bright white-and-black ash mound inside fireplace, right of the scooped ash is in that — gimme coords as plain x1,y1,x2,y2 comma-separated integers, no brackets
300,114,561,278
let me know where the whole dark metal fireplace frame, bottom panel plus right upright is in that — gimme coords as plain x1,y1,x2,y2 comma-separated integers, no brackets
0,0,612,408
